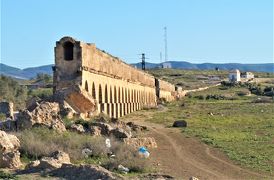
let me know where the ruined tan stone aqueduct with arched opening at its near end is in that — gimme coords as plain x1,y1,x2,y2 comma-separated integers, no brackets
53,37,175,118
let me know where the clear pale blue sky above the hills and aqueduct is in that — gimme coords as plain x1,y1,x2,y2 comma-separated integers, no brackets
1,0,273,68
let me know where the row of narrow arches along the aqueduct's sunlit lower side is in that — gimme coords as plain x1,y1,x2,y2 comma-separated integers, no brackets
84,81,156,118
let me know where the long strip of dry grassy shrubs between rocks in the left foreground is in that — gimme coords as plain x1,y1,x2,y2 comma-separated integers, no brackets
15,127,149,172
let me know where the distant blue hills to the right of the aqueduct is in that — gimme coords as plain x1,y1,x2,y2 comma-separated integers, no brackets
132,61,274,73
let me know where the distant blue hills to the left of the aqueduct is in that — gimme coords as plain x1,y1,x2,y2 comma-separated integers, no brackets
0,63,53,79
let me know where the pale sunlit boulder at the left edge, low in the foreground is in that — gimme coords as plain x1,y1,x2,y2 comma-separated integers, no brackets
0,131,22,168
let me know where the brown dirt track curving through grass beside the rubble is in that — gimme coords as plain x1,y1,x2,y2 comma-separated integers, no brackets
132,121,271,179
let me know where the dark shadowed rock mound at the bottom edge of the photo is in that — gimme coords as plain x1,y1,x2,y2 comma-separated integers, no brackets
50,164,119,180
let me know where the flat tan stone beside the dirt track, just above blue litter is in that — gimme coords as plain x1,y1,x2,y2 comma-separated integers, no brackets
123,137,157,148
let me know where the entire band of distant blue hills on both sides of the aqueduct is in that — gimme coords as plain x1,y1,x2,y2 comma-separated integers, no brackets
0,61,274,79
